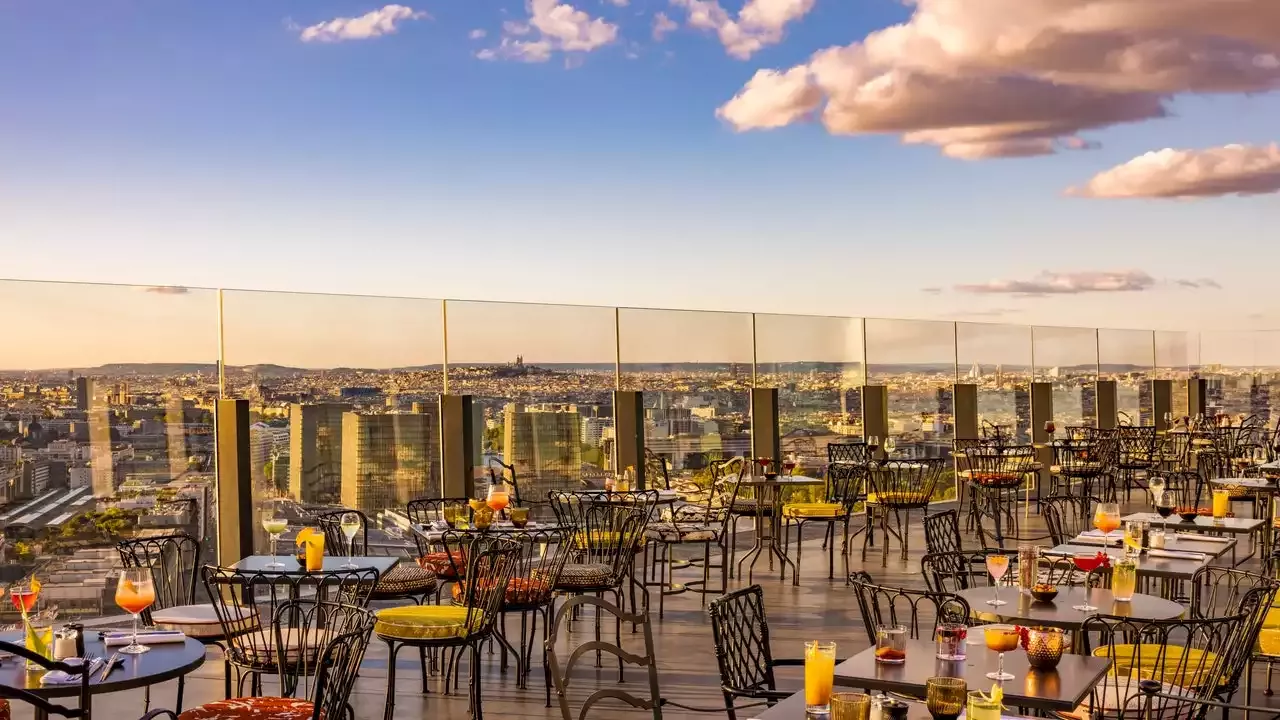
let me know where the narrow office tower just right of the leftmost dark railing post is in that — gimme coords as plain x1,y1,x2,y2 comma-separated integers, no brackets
289,402,351,505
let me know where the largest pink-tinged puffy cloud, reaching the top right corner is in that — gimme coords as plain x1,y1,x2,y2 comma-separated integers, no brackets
716,0,1280,159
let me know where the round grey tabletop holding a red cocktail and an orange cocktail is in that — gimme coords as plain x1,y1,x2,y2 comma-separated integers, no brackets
957,587,1187,627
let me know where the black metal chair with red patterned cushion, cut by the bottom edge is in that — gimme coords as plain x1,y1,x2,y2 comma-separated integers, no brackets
156,600,374,720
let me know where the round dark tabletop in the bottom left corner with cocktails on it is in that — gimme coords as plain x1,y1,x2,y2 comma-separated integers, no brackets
0,629,205,720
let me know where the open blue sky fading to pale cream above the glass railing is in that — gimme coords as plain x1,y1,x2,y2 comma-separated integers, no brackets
0,0,1280,328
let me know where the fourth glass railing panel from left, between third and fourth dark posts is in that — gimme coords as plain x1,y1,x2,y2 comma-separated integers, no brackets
618,309,753,477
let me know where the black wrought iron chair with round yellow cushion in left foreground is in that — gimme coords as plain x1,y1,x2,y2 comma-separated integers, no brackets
374,530,522,720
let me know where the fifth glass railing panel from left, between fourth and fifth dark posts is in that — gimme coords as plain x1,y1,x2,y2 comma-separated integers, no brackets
755,315,865,471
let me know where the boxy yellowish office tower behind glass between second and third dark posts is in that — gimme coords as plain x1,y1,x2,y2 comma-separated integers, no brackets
503,402,582,498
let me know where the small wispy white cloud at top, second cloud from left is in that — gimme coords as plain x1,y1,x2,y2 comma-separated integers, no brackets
476,0,618,63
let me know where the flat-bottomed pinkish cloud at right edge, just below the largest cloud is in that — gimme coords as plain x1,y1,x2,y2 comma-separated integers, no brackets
1068,143,1280,197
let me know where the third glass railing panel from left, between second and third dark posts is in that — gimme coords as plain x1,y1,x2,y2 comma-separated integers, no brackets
447,300,617,501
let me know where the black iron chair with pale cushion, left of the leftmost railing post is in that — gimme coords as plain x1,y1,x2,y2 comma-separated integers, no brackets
115,533,232,712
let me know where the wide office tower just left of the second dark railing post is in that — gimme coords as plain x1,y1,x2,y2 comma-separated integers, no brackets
342,413,440,515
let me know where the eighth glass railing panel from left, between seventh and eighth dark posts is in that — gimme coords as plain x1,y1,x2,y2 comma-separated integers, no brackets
1032,327,1098,428
